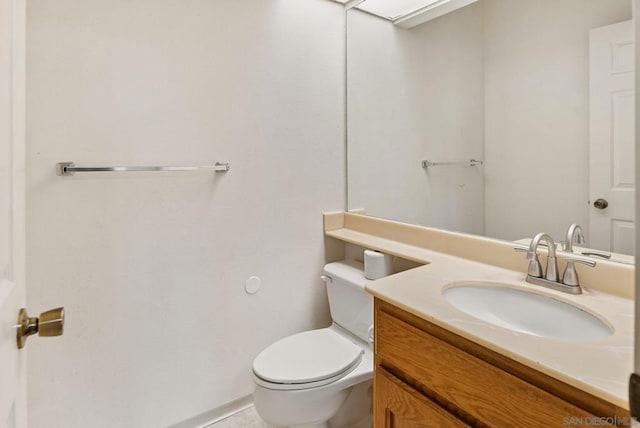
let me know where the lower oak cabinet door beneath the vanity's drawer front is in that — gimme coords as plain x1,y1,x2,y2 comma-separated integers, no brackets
373,367,467,428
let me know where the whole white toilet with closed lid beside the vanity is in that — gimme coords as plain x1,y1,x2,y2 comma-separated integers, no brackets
253,260,373,428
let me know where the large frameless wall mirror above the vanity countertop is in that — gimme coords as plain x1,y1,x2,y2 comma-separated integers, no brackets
347,0,635,262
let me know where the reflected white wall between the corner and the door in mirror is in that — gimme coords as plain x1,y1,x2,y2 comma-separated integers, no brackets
483,0,631,239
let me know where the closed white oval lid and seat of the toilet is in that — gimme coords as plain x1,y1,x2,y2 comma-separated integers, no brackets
253,328,364,384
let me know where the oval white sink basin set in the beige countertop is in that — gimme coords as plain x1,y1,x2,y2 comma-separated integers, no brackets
442,284,613,341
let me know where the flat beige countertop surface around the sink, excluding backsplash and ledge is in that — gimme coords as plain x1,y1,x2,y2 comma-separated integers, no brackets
366,254,634,409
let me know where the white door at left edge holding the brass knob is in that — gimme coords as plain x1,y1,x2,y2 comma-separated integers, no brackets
0,0,26,428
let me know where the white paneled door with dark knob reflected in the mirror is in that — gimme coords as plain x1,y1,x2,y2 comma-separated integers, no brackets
587,21,635,254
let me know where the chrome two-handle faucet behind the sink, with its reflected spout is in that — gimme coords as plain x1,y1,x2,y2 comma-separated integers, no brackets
514,231,596,294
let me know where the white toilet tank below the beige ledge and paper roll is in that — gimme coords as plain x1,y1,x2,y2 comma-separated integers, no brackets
324,260,373,342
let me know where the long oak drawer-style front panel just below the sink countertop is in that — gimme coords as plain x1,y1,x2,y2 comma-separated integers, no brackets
375,311,592,428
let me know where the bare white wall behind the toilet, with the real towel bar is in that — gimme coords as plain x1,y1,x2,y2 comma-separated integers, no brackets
27,0,345,427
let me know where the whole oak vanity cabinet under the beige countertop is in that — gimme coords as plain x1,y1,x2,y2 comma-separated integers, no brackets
374,298,630,428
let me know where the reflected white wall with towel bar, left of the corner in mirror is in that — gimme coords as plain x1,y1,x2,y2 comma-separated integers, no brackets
347,4,484,233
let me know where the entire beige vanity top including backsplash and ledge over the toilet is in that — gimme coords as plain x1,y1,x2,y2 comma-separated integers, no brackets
324,213,635,409
